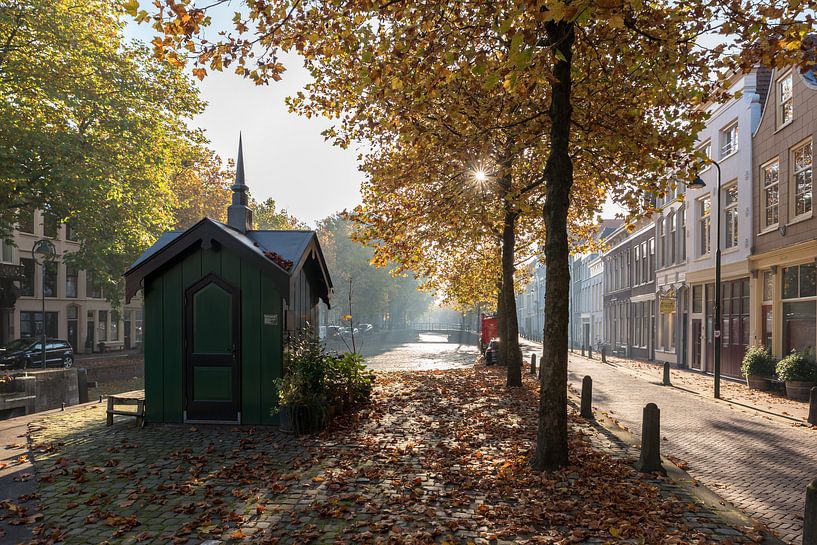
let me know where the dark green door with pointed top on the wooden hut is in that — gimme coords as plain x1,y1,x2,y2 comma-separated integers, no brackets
185,274,241,422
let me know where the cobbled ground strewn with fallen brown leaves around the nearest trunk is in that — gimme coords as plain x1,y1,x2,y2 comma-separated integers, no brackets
9,366,754,544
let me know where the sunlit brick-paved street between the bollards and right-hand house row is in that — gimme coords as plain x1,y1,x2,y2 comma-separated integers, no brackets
525,342,817,543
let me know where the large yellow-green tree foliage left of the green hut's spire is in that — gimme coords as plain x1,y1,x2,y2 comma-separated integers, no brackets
0,0,210,302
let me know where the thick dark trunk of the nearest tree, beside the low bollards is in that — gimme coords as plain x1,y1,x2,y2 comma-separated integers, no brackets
533,21,575,471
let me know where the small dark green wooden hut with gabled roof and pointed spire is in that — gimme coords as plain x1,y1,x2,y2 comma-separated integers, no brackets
125,139,332,424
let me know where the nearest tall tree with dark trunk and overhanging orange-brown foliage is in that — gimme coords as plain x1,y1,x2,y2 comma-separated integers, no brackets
143,0,816,470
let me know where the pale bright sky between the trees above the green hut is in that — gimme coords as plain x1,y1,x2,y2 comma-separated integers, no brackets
126,24,363,226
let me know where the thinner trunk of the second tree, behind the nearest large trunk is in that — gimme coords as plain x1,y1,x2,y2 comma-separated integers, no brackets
502,211,522,388
